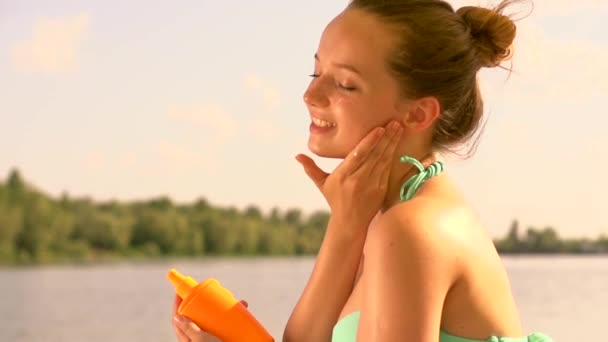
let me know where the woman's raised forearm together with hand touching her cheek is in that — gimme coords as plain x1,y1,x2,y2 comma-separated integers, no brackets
283,122,402,342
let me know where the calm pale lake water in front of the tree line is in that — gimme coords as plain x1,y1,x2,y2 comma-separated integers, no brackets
0,256,608,342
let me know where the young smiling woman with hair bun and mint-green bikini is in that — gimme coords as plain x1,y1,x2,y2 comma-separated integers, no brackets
174,0,550,342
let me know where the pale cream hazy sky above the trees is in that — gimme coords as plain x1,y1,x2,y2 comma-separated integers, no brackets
0,0,608,238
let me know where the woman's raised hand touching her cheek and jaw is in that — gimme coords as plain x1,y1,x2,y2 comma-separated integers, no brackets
296,122,403,226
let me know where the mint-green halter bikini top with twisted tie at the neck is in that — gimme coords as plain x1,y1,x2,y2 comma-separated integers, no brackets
331,156,552,342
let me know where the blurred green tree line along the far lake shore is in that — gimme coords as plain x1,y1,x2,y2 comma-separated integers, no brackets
0,170,608,264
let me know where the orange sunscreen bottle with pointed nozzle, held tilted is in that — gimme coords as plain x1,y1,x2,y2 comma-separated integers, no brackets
167,269,274,342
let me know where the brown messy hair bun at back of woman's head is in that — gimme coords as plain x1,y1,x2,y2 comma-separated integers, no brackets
456,0,517,68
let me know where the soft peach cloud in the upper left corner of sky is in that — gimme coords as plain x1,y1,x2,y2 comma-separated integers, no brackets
12,13,89,73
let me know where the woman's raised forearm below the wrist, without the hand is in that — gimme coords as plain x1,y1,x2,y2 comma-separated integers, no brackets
283,218,367,342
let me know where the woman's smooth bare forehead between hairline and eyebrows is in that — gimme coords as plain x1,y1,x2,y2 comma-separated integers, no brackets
318,9,393,74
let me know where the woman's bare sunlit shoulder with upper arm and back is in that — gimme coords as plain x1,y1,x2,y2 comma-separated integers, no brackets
362,182,518,341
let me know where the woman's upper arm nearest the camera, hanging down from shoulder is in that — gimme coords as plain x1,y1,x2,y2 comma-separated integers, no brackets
357,201,458,342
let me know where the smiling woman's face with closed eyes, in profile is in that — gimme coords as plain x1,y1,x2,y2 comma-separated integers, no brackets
304,9,406,158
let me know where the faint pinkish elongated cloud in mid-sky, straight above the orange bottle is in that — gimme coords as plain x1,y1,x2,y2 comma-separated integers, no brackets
169,103,238,143
